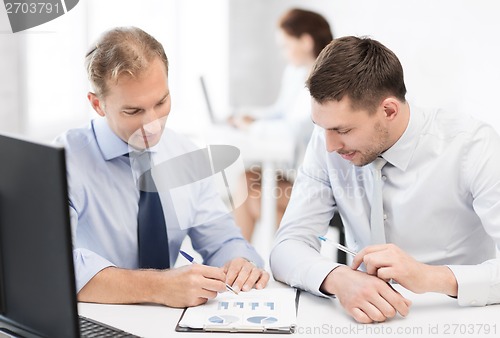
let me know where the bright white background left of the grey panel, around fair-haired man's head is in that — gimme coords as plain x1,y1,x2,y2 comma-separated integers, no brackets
0,0,229,141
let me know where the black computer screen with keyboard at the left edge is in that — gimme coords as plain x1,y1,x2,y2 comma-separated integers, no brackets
0,134,139,338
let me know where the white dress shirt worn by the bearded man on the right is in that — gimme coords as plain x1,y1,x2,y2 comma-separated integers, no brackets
270,106,500,305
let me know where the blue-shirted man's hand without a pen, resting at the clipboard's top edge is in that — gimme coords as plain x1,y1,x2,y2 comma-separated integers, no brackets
224,258,269,292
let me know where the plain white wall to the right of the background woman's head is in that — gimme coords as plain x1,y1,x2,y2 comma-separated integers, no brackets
328,0,500,132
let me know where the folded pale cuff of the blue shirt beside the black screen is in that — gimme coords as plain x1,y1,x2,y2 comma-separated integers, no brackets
73,249,115,293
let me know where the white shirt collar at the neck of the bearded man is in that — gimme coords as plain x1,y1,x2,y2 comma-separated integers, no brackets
382,102,424,171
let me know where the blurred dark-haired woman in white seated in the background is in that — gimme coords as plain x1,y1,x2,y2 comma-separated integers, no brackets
230,8,333,240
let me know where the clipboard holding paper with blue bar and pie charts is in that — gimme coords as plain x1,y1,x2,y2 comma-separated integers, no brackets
175,287,300,334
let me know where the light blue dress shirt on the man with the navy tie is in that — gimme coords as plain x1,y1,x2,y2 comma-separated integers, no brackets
56,118,263,291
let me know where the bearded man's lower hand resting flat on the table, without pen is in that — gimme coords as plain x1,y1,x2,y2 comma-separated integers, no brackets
320,266,411,324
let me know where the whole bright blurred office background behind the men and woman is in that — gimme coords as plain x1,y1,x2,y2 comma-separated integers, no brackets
0,0,500,256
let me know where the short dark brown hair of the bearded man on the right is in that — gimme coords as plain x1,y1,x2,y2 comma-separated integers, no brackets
307,36,406,112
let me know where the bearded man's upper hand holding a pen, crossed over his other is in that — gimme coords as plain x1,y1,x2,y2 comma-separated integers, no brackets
352,244,458,296
